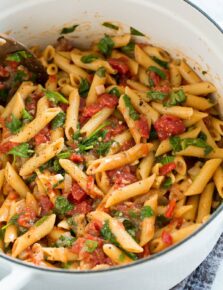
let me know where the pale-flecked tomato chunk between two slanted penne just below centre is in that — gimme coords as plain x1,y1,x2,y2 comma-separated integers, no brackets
107,165,137,188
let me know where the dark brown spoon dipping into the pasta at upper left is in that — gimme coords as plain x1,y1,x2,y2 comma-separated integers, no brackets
0,33,47,103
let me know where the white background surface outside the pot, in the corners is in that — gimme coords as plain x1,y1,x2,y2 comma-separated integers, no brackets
0,0,223,290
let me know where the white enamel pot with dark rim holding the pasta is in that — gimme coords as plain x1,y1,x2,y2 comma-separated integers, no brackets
0,0,223,290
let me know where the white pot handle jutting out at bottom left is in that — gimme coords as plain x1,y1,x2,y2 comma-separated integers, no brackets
0,267,33,290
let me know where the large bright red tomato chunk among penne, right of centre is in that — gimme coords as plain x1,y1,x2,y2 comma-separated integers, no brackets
154,115,186,140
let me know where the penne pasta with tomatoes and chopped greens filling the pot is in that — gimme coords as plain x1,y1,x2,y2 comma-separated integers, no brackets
0,24,223,270
